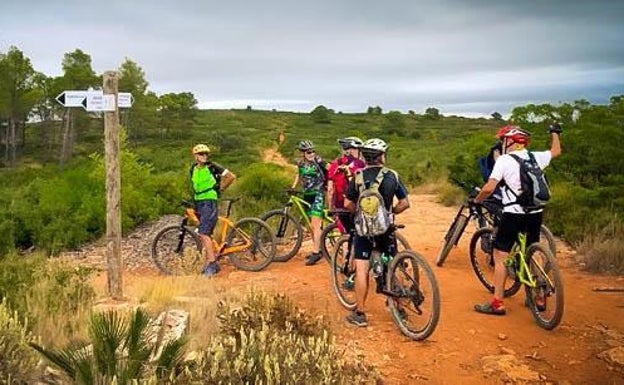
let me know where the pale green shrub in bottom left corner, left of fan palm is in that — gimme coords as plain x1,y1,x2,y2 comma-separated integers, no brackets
0,301,38,385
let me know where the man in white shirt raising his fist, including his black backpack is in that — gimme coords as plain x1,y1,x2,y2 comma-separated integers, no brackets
474,123,562,315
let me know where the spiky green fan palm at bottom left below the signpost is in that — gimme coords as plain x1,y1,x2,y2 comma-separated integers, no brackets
30,309,187,385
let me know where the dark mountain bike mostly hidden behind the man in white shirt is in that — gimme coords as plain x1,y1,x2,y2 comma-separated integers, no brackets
436,182,556,267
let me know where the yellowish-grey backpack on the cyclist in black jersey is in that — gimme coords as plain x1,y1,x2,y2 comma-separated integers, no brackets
354,167,392,237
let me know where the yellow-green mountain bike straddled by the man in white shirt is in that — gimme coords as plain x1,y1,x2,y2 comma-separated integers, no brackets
470,228,563,330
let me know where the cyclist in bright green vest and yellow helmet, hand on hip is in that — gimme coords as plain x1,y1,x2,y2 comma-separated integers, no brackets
189,144,236,277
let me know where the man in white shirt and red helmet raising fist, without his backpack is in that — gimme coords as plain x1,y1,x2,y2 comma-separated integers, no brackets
474,123,561,315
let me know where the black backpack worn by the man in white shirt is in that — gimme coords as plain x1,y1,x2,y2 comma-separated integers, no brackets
509,152,550,212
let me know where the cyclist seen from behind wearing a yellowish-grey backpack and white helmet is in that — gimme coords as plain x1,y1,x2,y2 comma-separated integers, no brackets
345,138,410,326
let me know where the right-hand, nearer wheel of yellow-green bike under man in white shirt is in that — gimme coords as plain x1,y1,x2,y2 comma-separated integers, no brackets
524,243,563,330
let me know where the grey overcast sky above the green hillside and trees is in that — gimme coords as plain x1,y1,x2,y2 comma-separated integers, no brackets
0,0,624,116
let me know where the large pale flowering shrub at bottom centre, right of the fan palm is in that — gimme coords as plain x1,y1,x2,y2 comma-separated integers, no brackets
191,293,376,384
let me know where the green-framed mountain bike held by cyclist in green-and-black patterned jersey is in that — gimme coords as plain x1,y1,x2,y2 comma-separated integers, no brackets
260,189,337,262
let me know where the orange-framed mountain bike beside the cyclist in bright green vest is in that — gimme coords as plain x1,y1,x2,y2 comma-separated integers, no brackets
151,198,276,275
